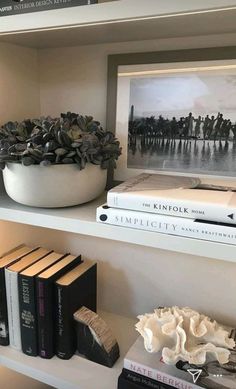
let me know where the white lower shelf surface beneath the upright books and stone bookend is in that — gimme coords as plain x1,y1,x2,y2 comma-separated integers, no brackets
0,312,138,389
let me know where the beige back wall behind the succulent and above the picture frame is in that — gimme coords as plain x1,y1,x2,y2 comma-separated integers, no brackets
39,34,236,124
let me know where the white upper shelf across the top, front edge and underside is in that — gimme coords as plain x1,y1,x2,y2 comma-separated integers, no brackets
0,0,236,48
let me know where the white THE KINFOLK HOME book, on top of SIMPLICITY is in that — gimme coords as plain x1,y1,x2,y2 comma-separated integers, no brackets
107,173,236,224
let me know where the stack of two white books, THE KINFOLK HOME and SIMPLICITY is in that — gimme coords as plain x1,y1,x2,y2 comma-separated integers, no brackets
97,173,236,244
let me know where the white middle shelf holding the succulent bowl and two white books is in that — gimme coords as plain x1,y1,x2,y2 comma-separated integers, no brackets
0,189,236,262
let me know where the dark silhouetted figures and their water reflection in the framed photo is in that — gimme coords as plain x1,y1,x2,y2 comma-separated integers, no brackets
127,106,236,175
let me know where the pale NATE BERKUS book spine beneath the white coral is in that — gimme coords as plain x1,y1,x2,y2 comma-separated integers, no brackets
124,358,202,389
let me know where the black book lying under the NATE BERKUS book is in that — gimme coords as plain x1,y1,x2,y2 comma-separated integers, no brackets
118,369,173,389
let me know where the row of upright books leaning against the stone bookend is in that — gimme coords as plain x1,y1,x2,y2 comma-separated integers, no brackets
0,244,97,359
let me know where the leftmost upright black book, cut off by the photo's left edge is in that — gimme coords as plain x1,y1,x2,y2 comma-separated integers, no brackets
0,244,33,346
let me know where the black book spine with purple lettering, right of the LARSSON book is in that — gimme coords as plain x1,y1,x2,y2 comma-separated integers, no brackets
36,278,54,359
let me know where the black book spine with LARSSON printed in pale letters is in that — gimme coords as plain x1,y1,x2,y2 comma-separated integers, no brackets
18,274,38,356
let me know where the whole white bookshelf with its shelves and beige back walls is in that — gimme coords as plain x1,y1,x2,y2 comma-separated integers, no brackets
0,0,236,389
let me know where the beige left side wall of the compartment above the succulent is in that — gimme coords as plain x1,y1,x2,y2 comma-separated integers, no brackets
0,43,40,124
